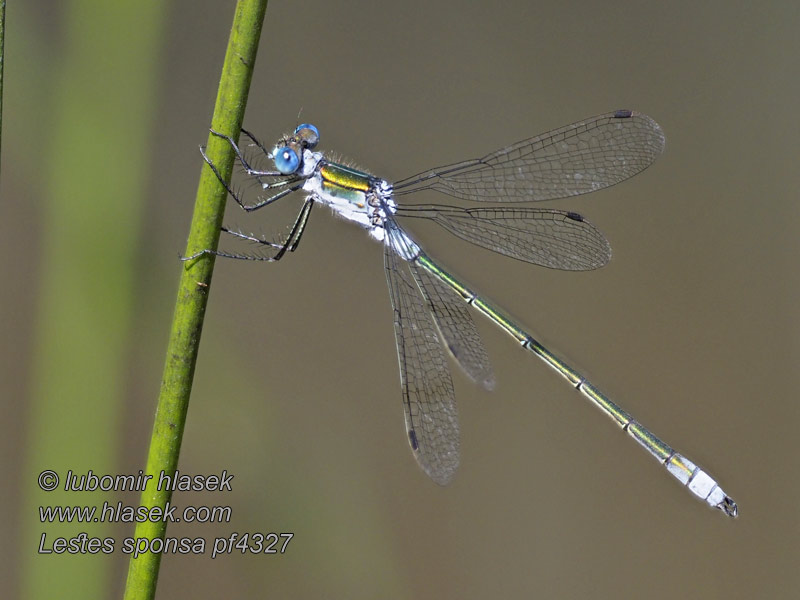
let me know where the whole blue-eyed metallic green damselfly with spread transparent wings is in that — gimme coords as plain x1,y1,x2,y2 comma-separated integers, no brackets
187,110,737,517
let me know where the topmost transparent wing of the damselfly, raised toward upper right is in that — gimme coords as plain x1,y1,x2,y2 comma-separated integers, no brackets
394,110,664,202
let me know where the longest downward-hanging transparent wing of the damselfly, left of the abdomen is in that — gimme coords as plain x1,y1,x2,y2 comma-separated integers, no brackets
383,232,459,485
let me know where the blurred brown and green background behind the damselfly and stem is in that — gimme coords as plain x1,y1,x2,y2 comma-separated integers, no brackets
0,0,800,599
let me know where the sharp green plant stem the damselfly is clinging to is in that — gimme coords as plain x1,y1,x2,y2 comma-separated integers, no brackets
125,0,267,600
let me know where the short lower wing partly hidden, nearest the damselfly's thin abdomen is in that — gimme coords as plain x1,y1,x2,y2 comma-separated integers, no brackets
409,263,494,390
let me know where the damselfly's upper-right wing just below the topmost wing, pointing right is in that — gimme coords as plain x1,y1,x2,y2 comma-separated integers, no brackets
397,204,611,271
